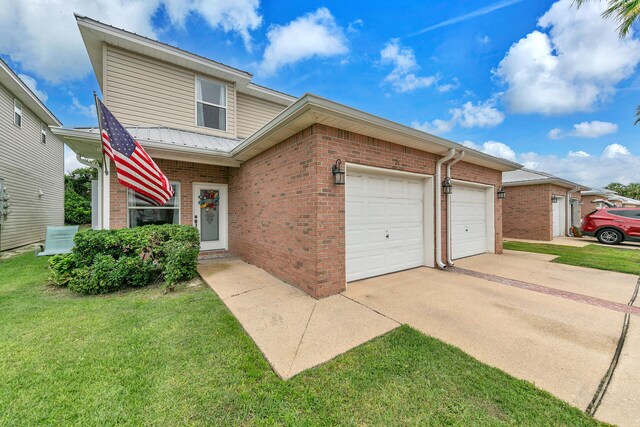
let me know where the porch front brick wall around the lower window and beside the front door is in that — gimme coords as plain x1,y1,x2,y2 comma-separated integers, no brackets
109,159,229,228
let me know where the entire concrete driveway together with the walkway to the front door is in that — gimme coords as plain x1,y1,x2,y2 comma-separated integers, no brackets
199,251,640,426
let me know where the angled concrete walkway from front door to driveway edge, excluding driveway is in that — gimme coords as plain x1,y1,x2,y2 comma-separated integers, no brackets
198,258,399,379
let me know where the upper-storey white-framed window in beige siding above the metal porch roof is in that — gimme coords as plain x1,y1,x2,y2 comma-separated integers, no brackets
196,78,227,131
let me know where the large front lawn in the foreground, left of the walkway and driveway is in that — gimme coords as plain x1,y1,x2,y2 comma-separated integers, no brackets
0,254,595,426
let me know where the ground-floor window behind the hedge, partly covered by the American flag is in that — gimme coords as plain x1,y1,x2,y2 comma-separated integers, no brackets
127,182,180,228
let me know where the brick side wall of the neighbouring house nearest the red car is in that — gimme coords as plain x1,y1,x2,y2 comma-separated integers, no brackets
502,184,579,241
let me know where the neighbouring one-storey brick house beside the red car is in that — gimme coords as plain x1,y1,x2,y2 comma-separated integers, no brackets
502,169,587,241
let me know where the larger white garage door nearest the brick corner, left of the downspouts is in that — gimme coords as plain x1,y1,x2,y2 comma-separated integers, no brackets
346,172,424,282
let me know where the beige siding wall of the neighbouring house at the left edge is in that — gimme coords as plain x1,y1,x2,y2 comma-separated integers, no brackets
0,84,64,250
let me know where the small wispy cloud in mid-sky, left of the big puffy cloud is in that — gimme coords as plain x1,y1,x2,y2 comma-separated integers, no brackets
380,39,440,93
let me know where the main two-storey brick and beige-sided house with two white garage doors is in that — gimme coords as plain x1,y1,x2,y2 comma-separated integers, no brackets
56,16,521,297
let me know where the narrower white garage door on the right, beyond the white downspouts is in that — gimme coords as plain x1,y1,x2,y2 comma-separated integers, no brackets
451,185,487,259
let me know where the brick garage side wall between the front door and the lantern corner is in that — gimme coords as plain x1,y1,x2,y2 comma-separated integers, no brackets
229,129,321,296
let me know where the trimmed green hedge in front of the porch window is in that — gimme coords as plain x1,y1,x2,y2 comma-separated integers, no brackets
49,225,200,294
